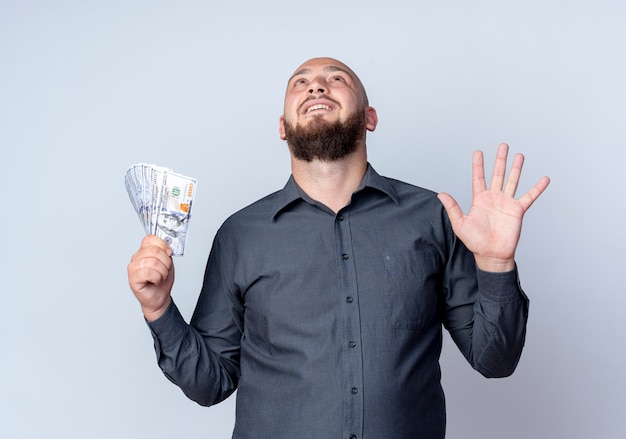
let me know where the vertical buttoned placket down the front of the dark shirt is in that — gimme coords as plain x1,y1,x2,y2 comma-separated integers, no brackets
335,209,364,439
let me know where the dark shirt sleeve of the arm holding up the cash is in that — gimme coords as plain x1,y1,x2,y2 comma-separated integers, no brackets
148,232,243,406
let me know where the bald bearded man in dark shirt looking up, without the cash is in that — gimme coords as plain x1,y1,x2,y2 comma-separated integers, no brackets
128,58,549,439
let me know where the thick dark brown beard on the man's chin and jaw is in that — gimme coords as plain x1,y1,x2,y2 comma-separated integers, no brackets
284,111,365,162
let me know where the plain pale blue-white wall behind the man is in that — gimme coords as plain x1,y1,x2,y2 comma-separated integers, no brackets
0,0,626,439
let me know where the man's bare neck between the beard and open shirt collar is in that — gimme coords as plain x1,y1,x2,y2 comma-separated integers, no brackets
291,148,367,213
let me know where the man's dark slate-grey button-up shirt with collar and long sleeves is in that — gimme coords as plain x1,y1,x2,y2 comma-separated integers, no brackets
150,166,528,439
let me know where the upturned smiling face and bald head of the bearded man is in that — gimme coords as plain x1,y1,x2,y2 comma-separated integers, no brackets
280,58,377,159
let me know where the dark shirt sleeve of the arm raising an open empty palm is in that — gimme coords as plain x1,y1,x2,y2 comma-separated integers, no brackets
443,230,529,378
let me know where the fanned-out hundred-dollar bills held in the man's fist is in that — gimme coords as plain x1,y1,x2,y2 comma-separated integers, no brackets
125,163,197,256
